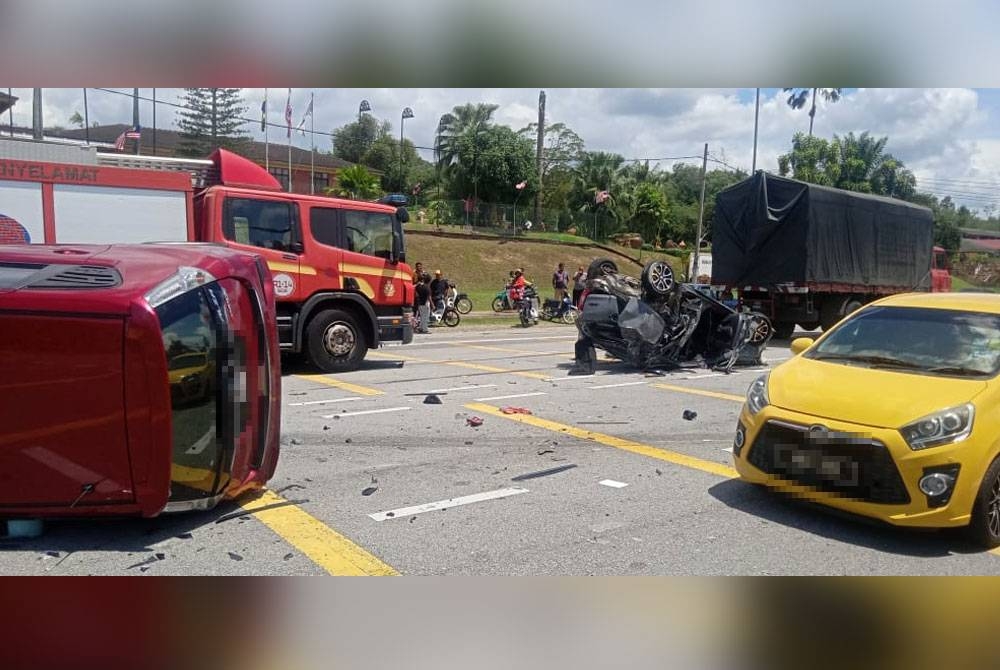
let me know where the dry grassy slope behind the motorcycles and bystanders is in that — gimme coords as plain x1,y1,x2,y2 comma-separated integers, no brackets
406,231,681,312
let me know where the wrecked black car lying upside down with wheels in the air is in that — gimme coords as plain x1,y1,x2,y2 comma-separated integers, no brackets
574,258,774,374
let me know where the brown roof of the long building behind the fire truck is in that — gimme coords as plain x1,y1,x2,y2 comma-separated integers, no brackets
45,123,353,170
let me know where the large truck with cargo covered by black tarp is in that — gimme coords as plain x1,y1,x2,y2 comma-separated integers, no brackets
712,172,951,338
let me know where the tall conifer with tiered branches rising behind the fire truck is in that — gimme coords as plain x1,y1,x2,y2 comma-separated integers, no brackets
177,88,248,157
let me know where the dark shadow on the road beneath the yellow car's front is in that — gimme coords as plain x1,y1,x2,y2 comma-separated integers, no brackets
708,479,983,558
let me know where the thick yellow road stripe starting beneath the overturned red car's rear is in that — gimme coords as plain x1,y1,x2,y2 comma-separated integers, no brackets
241,491,399,577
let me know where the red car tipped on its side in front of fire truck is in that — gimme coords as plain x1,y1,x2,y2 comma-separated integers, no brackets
0,244,281,518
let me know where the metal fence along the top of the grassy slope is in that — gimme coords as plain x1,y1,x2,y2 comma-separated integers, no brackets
410,200,617,240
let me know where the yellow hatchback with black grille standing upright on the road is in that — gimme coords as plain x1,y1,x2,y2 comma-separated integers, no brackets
733,293,1000,548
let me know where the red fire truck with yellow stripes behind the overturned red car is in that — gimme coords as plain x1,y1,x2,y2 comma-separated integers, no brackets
0,140,413,372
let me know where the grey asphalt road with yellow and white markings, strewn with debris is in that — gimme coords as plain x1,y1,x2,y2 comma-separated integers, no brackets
0,323,1000,575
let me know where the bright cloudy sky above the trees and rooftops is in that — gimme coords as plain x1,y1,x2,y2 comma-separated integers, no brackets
7,88,1000,212
